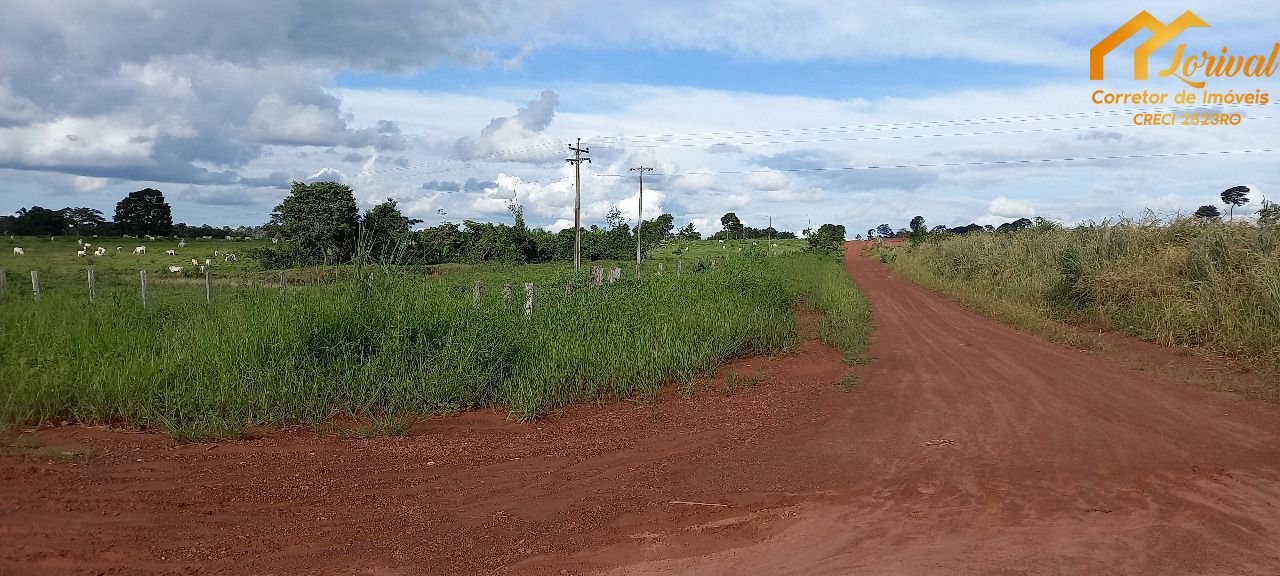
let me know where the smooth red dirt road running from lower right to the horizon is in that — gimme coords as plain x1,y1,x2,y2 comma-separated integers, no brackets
608,243,1280,575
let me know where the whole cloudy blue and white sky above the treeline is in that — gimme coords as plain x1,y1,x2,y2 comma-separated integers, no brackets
0,0,1280,237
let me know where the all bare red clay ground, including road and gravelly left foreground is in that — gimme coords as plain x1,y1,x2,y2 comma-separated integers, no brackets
0,244,1280,575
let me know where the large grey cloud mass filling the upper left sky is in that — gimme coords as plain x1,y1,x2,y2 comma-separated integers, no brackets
0,0,537,190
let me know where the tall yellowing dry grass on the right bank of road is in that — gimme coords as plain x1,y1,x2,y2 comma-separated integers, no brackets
886,218,1280,381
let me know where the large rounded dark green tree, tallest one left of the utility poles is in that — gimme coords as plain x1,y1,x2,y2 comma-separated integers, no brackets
264,182,360,265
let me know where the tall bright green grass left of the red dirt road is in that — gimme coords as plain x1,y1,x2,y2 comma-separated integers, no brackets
0,253,869,439
